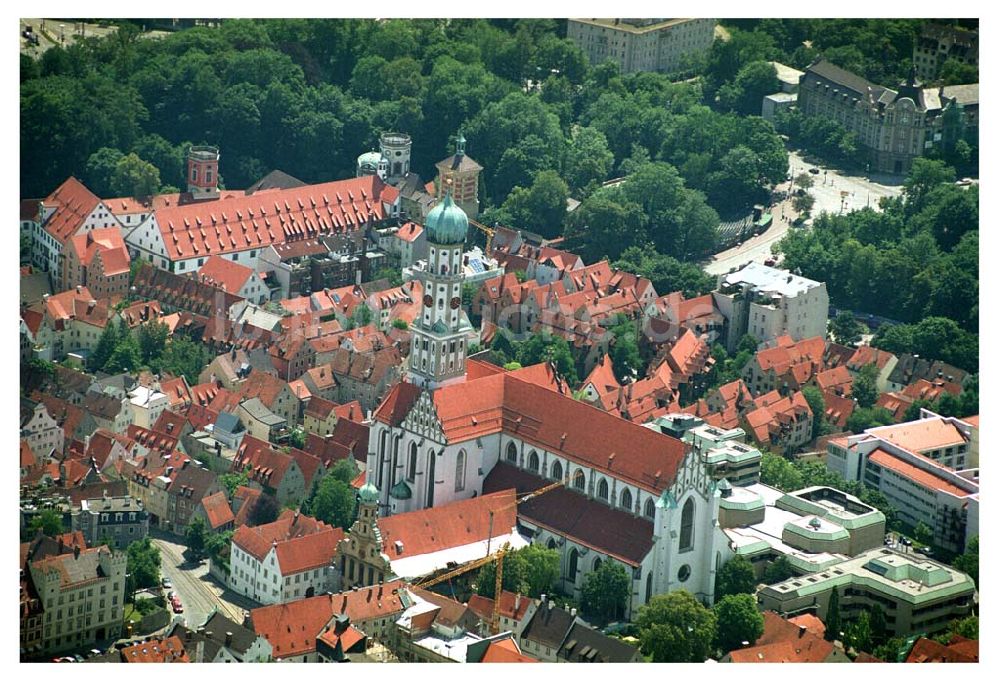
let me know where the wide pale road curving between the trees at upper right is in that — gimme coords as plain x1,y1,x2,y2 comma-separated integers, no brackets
703,151,902,275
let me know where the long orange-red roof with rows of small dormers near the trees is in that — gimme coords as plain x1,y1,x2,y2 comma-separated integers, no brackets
155,175,398,260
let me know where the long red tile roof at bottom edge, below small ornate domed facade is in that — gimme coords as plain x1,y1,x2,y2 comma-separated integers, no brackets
250,580,404,659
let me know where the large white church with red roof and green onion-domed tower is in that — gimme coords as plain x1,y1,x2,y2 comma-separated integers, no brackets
366,187,727,616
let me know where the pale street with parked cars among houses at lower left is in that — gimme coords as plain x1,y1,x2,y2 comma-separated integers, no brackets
151,533,259,627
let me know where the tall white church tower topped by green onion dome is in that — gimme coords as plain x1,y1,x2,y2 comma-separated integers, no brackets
409,192,469,389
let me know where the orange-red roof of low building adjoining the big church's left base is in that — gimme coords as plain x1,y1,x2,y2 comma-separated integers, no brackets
378,490,517,559
